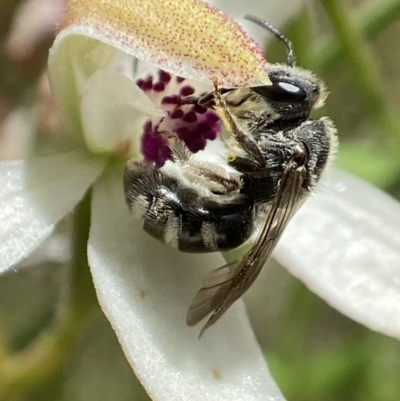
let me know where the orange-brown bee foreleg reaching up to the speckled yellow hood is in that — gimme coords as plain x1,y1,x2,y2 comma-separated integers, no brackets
214,80,265,169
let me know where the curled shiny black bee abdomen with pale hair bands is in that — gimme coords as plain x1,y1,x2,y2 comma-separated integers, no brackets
124,162,254,252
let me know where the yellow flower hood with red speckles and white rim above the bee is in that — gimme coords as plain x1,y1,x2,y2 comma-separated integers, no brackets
61,0,270,87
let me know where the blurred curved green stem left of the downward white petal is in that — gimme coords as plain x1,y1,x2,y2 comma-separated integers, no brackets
0,192,97,401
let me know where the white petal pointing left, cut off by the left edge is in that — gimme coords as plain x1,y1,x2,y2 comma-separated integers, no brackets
0,151,103,273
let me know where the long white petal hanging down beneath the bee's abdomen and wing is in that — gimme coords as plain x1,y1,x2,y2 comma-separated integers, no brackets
88,165,283,401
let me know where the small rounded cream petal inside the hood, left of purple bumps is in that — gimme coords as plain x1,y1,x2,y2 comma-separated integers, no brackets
81,70,164,156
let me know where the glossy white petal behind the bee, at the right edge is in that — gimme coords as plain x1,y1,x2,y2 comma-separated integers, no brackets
276,170,400,338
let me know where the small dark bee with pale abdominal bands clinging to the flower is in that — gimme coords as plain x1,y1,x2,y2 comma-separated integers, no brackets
124,15,336,334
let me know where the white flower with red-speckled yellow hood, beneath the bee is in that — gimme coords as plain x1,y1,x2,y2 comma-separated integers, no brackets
0,0,400,400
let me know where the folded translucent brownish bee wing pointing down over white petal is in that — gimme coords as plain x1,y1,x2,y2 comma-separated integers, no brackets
186,155,306,337
